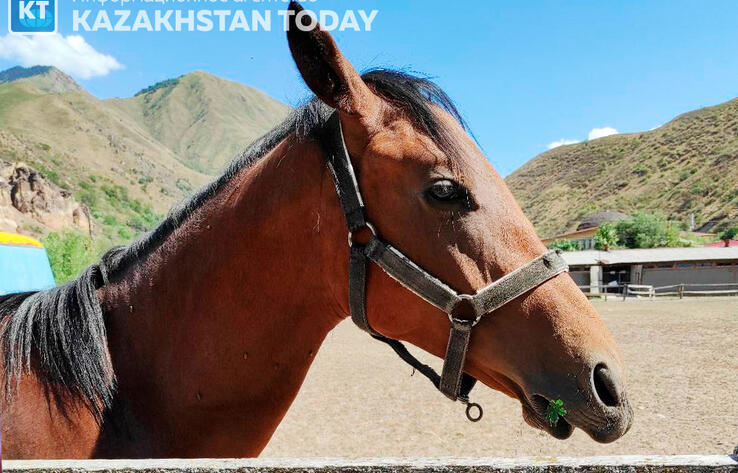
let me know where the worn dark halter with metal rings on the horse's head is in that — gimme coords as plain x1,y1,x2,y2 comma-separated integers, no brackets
324,111,569,422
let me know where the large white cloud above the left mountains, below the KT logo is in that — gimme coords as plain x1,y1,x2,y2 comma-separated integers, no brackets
0,33,123,79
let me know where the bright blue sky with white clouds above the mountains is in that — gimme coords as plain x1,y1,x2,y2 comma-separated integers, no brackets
0,0,738,175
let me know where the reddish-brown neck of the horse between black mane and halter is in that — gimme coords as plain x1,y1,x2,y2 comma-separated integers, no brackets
98,132,345,455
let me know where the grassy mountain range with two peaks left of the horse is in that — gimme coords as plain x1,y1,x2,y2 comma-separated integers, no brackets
0,66,288,243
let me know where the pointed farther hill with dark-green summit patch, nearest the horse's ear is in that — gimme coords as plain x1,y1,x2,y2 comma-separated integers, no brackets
108,71,290,174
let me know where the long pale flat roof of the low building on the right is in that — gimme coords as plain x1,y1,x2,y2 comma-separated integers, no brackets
563,246,738,266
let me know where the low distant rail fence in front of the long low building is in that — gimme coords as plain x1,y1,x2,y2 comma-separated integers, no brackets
579,283,738,300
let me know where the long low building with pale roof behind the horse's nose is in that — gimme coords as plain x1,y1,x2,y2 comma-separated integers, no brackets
564,246,738,292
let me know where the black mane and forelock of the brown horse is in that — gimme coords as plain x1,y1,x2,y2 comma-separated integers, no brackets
0,69,466,422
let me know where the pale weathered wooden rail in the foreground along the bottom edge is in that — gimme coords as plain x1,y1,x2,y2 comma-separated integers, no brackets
3,455,738,473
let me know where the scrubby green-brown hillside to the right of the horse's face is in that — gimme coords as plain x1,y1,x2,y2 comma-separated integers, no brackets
506,99,738,237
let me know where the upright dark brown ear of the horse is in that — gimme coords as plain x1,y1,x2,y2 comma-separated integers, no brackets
287,0,379,116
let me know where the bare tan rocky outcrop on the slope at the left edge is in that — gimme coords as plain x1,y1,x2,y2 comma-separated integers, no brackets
0,161,92,233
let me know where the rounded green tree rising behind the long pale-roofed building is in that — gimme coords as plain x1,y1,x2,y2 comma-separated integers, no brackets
615,213,682,248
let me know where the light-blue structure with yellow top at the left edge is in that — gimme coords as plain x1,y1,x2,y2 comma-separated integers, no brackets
0,232,54,296
